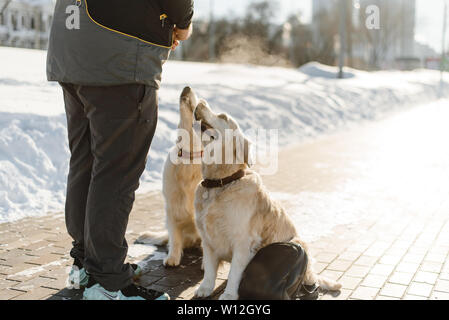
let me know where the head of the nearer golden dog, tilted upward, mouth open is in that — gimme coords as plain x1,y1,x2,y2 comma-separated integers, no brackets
194,99,252,167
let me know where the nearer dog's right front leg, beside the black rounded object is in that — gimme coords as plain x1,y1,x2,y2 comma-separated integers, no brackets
220,248,252,300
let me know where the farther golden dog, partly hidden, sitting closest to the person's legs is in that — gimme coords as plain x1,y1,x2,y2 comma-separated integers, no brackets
136,87,202,267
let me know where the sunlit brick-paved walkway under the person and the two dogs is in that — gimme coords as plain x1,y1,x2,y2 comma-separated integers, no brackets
0,101,449,300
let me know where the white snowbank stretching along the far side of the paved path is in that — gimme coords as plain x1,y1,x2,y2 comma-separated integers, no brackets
0,48,447,222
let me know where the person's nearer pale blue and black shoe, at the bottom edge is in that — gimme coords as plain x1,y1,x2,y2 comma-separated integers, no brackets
83,283,170,300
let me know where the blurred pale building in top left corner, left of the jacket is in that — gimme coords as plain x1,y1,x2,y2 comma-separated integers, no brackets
0,0,56,49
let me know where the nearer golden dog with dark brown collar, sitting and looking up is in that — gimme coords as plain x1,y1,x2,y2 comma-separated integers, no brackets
195,100,341,300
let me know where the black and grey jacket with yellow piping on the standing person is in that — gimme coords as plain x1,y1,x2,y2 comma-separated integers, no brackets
47,0,193,88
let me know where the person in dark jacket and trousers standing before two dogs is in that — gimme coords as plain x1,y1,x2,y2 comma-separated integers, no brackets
47,0,193,300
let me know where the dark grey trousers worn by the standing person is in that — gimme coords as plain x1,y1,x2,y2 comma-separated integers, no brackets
61,83,158,291
